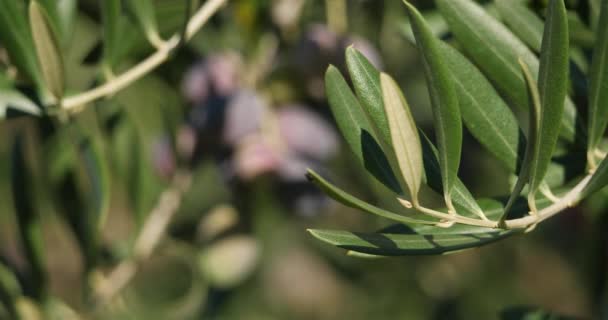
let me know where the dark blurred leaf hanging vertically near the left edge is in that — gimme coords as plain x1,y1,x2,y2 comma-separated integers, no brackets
10,134,48,299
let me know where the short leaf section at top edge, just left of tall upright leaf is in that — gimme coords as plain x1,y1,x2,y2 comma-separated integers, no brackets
494,1,543,52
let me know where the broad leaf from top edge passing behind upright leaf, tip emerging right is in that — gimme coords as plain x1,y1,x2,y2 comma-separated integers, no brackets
437,0,577,142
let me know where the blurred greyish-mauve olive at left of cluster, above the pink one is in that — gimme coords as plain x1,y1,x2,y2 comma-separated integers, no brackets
222,89,269,145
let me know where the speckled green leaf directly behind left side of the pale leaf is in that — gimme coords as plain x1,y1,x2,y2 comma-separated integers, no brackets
346,46,391,145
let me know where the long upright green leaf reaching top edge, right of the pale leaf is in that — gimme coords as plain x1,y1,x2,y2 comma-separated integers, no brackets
405,2,462,208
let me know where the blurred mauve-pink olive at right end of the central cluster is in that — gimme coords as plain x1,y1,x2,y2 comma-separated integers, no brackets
278,105,338,161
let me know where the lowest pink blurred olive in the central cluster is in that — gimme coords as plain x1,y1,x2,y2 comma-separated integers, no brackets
232,136,281,181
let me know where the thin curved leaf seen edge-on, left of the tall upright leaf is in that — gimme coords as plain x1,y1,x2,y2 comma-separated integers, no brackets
500,60,541,222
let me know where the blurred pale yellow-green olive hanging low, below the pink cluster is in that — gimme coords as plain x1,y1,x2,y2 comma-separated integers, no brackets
199,235,260,289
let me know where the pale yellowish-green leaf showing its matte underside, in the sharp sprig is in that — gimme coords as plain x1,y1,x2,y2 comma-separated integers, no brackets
380,73,423,203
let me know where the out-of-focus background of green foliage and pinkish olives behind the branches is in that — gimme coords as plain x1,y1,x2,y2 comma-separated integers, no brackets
0,0,608,319
